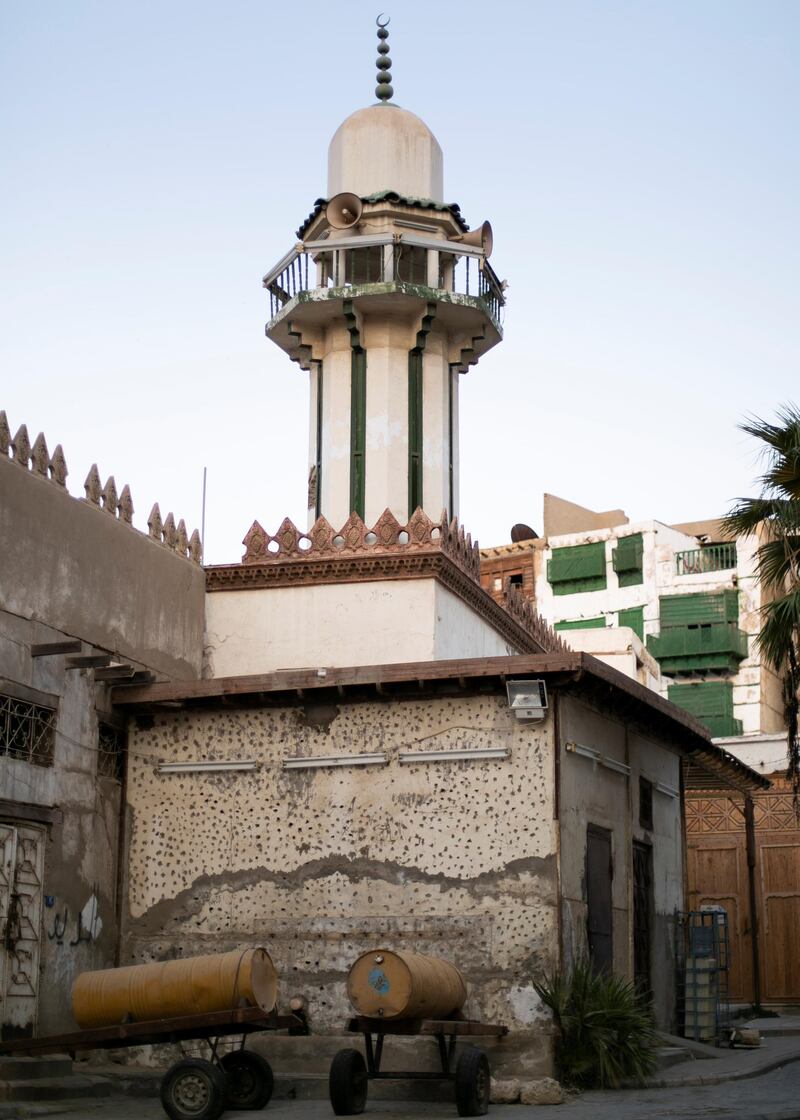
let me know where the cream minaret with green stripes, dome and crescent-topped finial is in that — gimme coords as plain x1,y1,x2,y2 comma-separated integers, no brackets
263,17,504,526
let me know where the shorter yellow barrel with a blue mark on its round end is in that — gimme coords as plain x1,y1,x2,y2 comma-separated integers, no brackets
347,949,466,1019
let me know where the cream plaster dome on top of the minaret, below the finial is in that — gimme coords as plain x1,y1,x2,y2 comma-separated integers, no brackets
328,104,444,202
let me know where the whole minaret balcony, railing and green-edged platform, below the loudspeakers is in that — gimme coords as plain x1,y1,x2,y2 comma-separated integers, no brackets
263,233,505,367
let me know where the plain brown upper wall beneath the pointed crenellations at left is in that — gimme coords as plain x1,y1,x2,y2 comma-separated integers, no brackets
0,455,205,679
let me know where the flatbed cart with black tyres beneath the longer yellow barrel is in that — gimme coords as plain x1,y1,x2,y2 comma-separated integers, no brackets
0,1007,303,1120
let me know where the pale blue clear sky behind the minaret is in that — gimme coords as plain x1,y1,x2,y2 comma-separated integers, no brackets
0,0,800,563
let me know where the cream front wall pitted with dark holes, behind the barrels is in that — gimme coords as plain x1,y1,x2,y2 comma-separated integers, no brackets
123,694,558,1030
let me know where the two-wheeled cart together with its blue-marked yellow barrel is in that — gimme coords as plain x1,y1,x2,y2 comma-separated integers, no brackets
328,949,508,1117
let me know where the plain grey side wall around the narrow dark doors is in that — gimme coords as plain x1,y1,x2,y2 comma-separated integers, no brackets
559,694,683,1029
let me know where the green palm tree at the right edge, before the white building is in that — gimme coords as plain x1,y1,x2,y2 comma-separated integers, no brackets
723,404,800,815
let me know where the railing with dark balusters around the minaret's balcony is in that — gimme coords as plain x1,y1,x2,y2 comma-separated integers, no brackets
263,234,505,326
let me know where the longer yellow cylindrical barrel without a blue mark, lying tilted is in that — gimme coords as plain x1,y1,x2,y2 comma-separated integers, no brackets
72,949,278,1029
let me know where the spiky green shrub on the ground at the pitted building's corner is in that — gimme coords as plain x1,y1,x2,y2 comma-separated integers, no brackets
533,960,658,1089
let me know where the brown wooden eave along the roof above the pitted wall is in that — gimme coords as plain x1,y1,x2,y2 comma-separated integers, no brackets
111,651,770,792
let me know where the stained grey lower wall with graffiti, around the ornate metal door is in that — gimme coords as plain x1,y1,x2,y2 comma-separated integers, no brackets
0,610,121,1034
